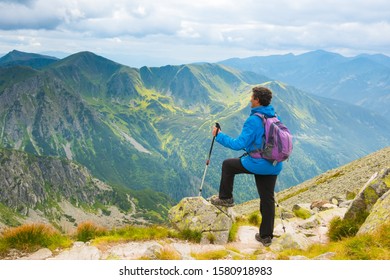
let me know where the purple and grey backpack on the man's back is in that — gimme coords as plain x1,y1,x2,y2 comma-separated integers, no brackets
249,113,292,165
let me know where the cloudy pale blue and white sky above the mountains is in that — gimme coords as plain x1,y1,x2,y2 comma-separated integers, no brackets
0,0,390,67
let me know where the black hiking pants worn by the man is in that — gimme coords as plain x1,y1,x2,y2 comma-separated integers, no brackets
219,158,277,238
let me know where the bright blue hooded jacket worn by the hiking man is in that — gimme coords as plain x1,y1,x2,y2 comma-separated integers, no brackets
215,105,283,175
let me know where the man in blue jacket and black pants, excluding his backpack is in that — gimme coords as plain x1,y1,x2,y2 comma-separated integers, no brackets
210,86,283,246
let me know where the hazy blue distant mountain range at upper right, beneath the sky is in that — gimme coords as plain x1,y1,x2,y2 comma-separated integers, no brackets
221,51,390,119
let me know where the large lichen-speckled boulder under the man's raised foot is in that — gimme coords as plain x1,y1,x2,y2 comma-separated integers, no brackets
168,196,233,244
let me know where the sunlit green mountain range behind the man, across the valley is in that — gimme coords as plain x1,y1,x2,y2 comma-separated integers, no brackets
0,52,390,207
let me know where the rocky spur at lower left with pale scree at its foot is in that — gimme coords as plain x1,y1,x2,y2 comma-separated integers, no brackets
0,149,141,232
